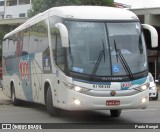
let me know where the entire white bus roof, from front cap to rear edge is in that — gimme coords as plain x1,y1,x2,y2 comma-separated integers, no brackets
4,6,138,39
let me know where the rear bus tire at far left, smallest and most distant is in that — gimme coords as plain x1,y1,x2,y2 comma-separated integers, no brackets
11,85,21,106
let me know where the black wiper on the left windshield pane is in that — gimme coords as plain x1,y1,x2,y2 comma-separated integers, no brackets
92,39,105,78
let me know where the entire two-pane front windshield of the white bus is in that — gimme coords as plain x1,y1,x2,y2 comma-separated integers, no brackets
65,21,147,77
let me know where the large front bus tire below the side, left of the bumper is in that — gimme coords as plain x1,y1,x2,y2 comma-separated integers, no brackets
46,87,60,116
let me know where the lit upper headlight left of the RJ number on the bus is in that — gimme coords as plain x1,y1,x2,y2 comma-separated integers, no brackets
63,81,90,93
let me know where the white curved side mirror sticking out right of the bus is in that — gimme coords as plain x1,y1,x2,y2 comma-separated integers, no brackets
142,24,158,48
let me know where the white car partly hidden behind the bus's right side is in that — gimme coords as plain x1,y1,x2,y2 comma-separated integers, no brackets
149,73,158,100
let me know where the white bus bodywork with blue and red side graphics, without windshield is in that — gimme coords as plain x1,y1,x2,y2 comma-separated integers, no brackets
3,6,156,113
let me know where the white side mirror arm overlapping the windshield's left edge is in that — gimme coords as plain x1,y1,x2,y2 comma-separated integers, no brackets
55,23,69,47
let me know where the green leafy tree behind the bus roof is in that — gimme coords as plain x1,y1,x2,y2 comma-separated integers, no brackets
28,0,114,17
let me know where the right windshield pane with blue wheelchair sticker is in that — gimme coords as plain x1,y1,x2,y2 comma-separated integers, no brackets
107,22,147,75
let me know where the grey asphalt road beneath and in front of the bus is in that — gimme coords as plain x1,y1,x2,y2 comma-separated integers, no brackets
0,91,160,132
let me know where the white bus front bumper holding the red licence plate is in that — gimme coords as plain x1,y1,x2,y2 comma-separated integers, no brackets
67,89,149,110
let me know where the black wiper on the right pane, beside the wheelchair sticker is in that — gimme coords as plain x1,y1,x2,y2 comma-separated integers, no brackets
114,40,134,79
